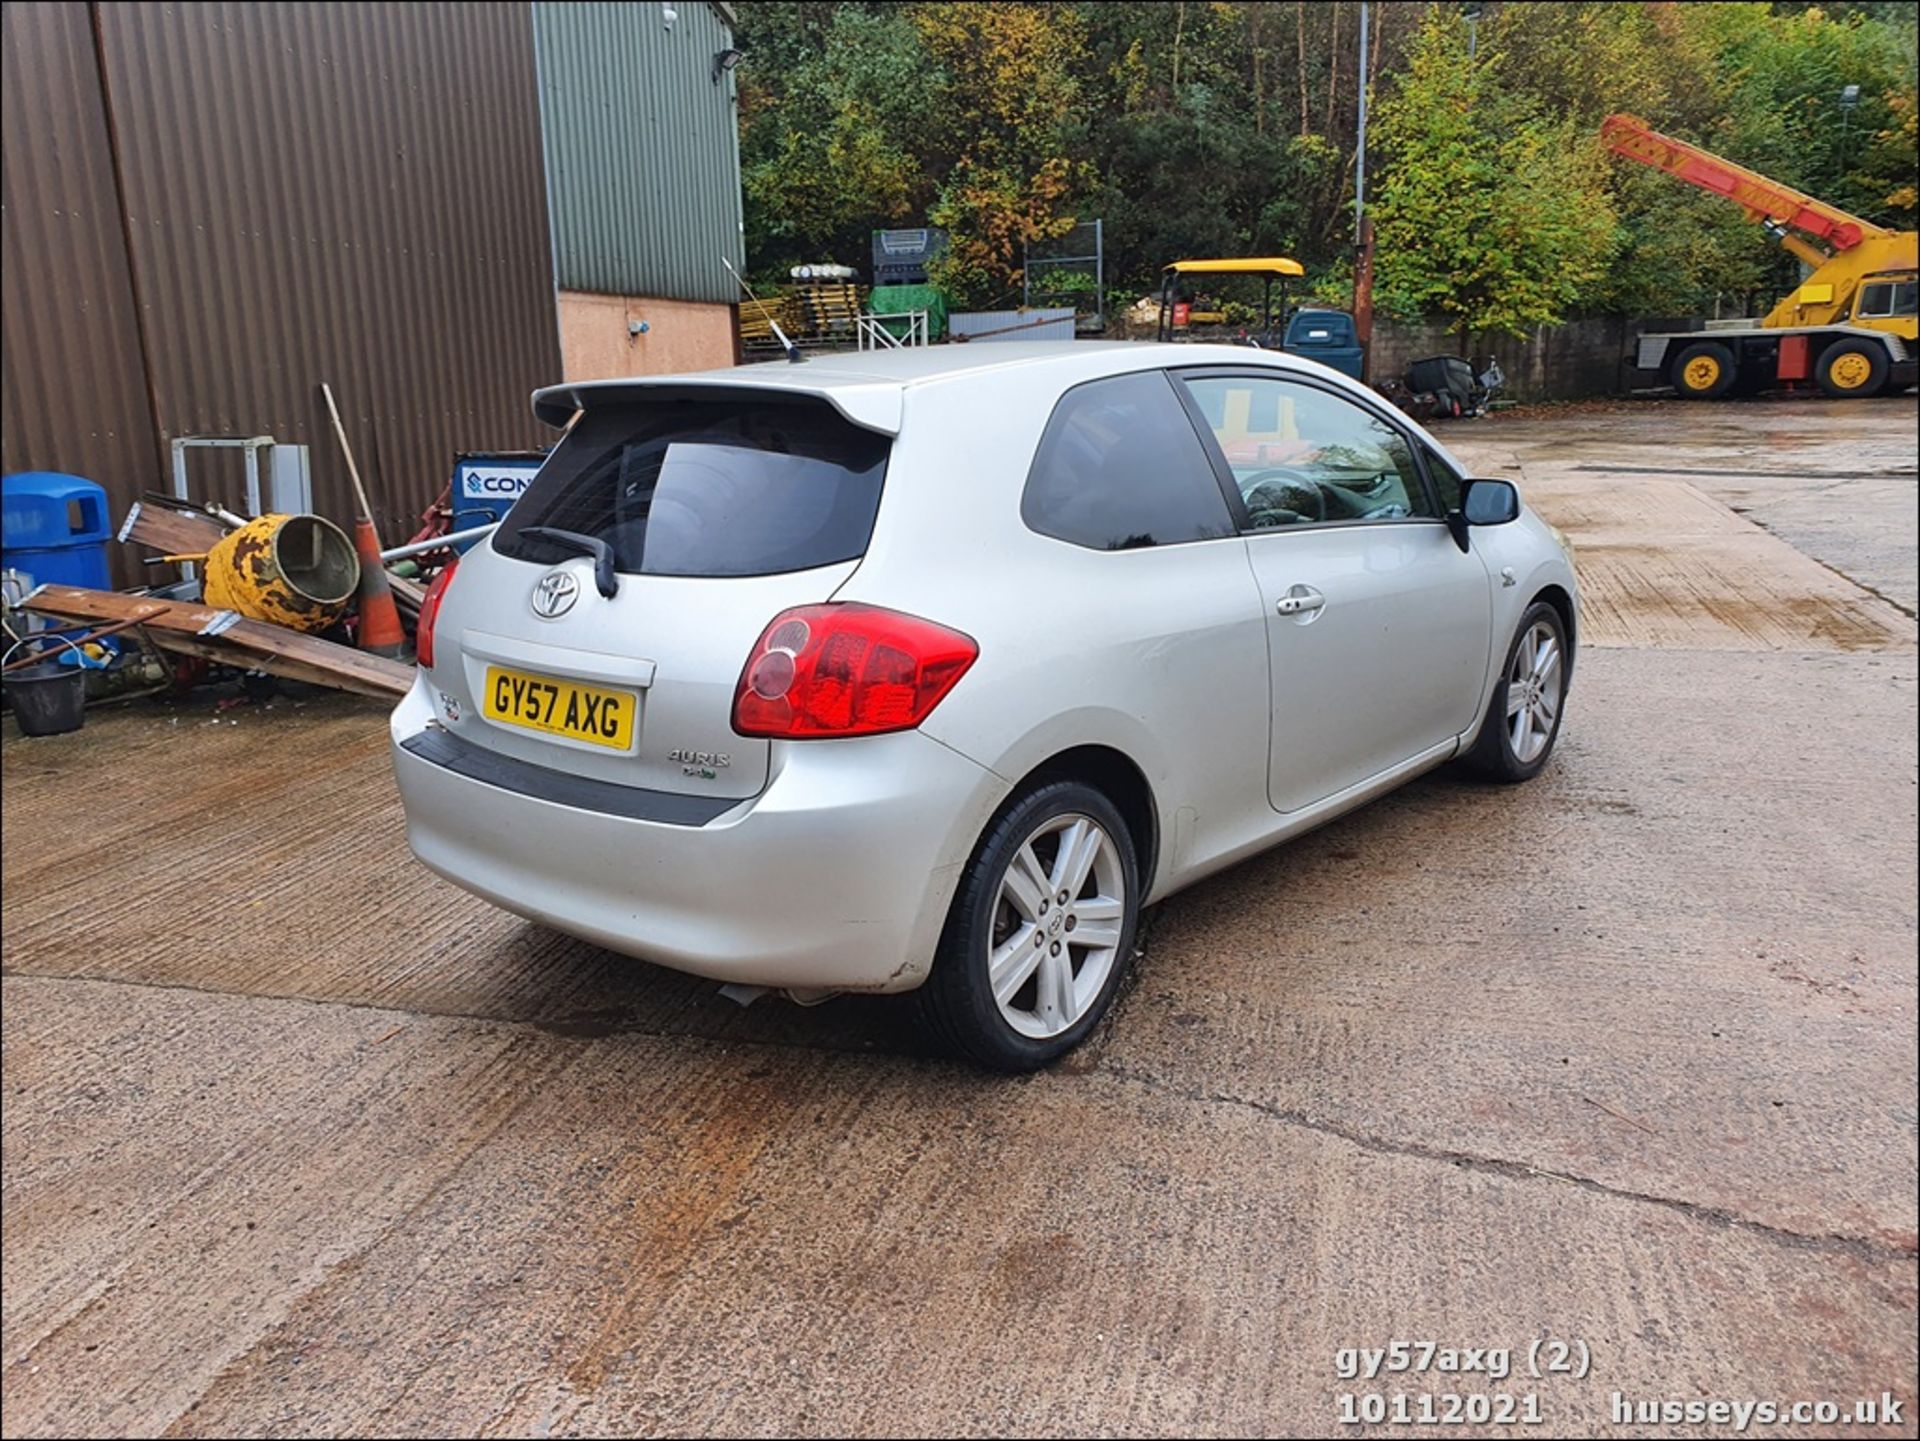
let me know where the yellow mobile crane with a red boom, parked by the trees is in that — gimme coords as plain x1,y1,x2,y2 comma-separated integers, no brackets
1599,115,1920,401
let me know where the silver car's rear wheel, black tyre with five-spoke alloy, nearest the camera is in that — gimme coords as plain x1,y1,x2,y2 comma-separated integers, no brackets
914,781,1140,1071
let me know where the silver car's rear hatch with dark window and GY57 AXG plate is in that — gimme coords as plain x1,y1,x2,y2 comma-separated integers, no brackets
432,390,891,798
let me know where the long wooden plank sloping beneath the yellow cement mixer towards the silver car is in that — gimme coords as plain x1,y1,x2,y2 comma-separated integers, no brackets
23,585,413,700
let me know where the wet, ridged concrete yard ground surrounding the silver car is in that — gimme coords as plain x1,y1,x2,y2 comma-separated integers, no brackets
0,401,1920,1435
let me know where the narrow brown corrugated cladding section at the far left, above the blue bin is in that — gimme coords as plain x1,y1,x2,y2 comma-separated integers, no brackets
0,4,159,567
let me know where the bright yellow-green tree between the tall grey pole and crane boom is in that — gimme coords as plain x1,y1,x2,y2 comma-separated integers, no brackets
1373,12,1615,349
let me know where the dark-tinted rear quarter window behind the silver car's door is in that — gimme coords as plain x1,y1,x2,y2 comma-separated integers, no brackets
1020,370,1235,551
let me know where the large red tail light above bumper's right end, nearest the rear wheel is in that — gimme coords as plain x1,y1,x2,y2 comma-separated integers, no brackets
733,602,979,741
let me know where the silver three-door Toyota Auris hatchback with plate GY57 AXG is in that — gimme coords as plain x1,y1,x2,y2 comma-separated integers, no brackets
392,343,1578,1069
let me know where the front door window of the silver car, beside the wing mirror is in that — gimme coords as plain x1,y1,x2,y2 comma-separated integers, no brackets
1185,376,1438,530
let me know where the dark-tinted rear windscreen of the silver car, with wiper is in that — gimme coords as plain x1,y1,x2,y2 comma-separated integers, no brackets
493,397,891,576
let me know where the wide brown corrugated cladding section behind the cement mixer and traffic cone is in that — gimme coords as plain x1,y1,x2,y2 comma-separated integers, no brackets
67,4,561,545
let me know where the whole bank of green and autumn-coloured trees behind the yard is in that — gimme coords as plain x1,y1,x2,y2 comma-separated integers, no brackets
737,0,1920,328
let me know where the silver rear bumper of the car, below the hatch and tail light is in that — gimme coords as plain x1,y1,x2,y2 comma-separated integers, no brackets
392,683,1006,990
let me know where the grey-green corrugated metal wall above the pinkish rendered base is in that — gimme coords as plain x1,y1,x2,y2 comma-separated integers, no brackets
534,0,745,305
